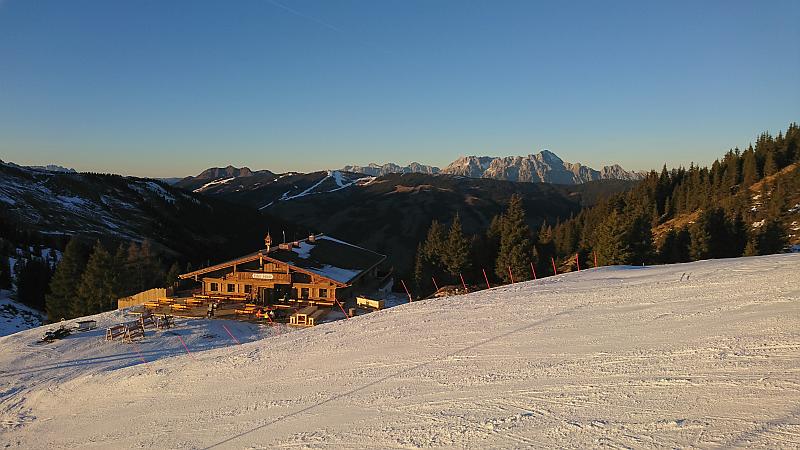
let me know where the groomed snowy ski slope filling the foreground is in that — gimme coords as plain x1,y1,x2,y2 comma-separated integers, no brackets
0,255,800,449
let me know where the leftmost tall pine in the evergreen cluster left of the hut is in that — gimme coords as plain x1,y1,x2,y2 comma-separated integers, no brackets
45,237,86,323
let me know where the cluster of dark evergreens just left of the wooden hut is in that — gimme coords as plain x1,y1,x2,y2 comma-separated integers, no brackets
44,237,173,322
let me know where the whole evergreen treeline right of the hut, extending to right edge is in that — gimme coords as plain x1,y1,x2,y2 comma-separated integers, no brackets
414,123,800,294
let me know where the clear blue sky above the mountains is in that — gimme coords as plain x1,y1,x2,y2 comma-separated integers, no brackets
0,0,800,176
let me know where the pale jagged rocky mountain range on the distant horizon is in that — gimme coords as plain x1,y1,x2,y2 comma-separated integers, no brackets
341,150,645,184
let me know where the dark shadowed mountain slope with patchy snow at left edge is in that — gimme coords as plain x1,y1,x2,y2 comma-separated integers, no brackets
0,162,288,260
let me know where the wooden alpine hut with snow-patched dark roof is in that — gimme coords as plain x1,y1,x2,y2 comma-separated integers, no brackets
180,235,386,305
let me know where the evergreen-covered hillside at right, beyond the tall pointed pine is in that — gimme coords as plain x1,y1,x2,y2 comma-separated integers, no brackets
552,123,800,264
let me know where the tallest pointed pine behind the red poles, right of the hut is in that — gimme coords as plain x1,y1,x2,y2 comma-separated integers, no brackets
495,194,533,282
